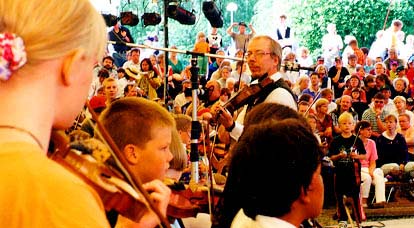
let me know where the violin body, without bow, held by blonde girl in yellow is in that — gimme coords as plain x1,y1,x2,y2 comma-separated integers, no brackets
49,131,148,221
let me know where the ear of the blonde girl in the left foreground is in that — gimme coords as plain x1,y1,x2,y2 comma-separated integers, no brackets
61,49,85,86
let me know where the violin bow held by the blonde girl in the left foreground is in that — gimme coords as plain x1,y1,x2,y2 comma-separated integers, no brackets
86,101,171,228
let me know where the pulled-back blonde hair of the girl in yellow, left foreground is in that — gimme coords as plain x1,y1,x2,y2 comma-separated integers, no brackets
0,0,107,67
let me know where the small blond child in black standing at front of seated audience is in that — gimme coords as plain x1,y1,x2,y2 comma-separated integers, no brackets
328,112,366,221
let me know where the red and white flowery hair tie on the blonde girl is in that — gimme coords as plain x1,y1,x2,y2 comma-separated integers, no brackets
0,32,27,81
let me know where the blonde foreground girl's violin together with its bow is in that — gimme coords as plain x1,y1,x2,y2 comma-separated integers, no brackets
49,102,171,228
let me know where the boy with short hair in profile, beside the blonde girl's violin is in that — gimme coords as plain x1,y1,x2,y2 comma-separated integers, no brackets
99,97,175,227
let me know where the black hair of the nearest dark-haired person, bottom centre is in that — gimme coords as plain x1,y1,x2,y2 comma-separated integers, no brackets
226,119,322,219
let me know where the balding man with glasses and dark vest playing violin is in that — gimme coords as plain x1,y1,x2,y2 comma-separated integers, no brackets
216,36,297,140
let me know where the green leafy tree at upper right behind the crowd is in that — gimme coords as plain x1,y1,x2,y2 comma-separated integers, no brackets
290,0,414,58
